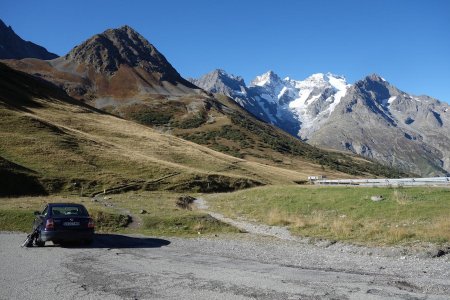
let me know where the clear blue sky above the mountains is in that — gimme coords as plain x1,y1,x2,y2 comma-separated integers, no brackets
0,0,450,102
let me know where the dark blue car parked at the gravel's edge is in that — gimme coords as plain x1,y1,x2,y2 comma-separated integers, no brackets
33,203,95,247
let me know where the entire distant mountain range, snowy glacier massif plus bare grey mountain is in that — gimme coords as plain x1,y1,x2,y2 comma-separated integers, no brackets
193,70,450,175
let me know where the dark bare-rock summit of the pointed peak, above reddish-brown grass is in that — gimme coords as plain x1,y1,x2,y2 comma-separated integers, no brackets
65,25,180,81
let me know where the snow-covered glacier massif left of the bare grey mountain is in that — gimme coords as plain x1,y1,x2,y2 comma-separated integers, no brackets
191,70,349,139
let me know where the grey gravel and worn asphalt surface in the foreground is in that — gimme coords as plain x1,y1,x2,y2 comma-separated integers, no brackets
0,233,450,299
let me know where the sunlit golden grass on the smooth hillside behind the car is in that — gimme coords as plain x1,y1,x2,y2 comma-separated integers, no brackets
0,95,320,195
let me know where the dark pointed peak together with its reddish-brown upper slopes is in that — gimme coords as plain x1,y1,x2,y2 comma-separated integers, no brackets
6,26,199,102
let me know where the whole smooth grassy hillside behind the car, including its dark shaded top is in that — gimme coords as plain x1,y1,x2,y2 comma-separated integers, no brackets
0,64,345,194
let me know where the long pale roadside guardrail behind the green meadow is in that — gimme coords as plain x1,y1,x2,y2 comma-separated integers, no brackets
313,177,450,186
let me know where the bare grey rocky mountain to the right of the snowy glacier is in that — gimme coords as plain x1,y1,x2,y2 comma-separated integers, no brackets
310,75,450,176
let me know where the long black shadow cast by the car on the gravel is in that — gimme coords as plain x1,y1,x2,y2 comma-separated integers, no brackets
55,233,170,249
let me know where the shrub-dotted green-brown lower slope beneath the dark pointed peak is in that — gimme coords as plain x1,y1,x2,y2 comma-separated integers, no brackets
107,94,406,177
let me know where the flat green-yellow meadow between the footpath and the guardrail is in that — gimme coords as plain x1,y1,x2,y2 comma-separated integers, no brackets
206,186,450,245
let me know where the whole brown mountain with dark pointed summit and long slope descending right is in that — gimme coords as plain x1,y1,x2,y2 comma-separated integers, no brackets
1,26,404,183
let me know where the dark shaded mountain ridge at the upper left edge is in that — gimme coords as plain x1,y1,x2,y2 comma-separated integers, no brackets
0,20,58,59
